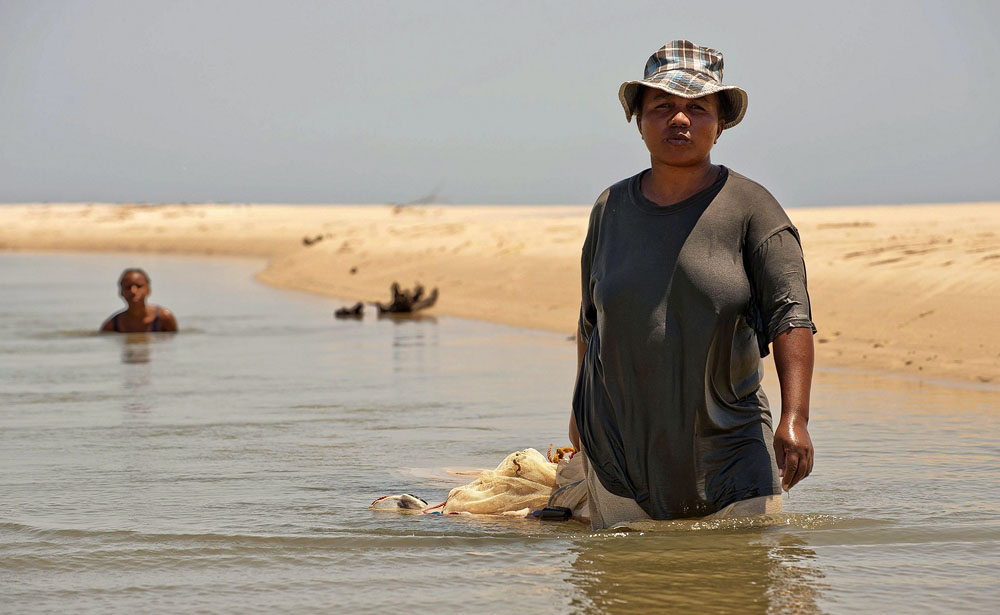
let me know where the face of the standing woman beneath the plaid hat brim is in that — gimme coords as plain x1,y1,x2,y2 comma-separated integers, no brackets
637,88,725,167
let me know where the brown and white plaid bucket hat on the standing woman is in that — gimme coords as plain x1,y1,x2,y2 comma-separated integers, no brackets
618,40,747,128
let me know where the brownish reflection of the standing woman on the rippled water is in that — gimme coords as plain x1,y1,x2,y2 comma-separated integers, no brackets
573,529,825,614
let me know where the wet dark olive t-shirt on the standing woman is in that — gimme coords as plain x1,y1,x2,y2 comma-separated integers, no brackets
573,167,815,519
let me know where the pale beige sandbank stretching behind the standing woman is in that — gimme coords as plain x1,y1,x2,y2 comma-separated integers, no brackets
0,203,1000,383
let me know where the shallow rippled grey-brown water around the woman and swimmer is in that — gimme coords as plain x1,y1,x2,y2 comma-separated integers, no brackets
0,253,1000,613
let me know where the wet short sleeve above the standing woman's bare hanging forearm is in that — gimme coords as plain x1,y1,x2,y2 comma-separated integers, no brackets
747,224,816,357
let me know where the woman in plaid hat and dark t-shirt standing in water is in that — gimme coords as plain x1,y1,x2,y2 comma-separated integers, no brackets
570,40,815,528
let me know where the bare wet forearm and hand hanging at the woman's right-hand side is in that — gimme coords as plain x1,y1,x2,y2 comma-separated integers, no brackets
773,327,813,491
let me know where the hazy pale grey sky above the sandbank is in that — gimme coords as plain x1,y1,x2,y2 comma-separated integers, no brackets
0,0,1000,207
